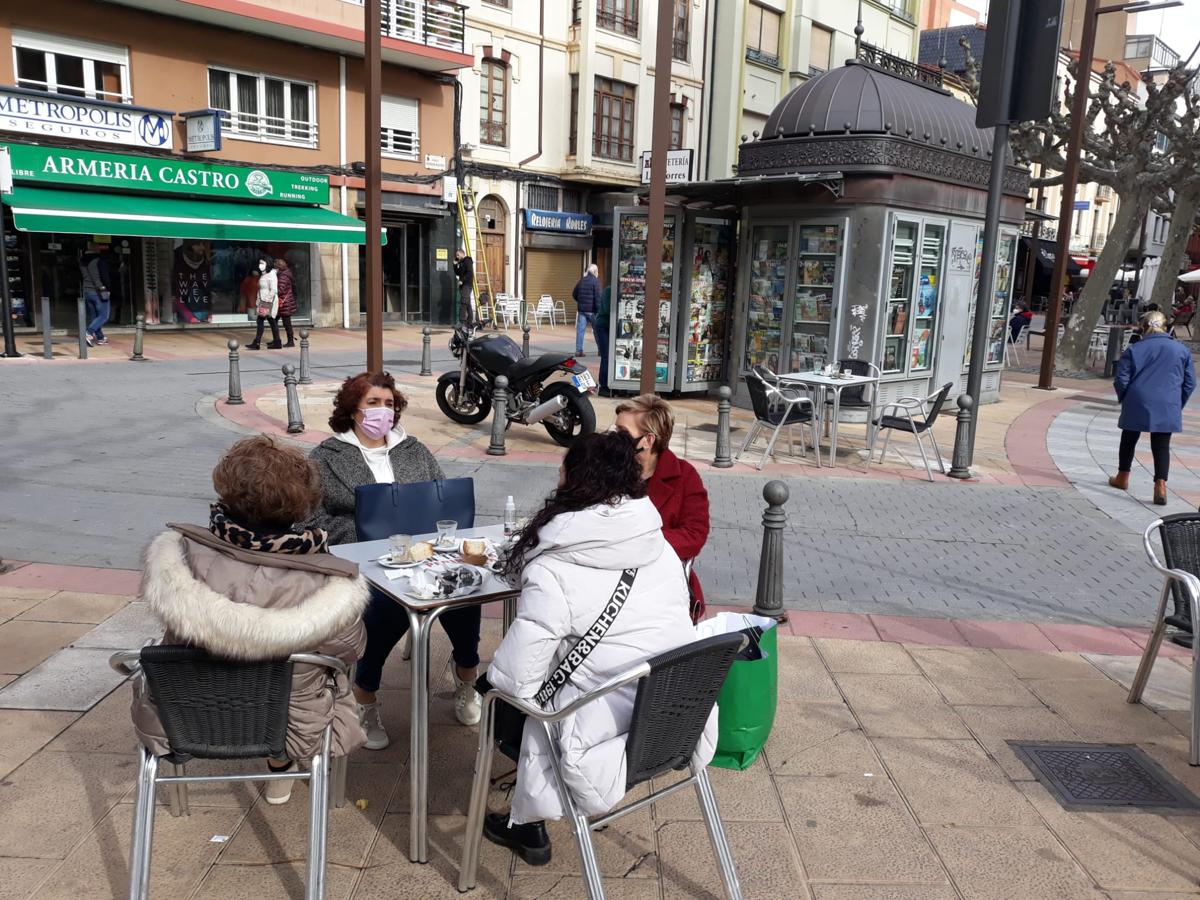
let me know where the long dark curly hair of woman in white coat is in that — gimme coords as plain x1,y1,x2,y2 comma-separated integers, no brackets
504,431,646,578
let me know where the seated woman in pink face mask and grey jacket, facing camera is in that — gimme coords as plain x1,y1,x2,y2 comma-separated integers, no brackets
311,372,480,750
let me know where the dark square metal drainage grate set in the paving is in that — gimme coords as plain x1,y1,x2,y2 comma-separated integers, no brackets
1008,740,1200,812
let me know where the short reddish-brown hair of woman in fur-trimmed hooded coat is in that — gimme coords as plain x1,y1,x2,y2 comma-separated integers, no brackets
212,434,320,528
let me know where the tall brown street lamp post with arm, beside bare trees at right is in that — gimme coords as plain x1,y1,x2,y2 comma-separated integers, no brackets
1038,0,1182,391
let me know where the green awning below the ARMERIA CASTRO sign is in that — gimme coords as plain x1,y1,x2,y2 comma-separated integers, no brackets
4,187,385,244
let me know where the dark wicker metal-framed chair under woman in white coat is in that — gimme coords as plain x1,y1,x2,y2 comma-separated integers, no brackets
458,634,746,900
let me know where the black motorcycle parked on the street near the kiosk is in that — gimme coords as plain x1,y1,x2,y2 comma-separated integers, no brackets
437,325,596,446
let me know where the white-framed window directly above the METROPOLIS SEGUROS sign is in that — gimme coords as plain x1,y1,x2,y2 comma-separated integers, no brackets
12,31,133,103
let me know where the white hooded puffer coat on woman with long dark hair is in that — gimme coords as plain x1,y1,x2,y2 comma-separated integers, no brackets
487,498,716,824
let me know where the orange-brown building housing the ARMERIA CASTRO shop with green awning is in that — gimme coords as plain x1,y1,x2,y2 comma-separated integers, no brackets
0,0,470,328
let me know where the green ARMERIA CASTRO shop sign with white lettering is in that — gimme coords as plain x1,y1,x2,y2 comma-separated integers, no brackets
8,144,329,206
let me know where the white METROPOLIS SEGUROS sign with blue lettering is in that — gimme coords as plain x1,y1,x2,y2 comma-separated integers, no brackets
0,88,174,150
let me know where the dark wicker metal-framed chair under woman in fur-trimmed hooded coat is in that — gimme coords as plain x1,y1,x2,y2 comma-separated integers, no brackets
109,644,349,900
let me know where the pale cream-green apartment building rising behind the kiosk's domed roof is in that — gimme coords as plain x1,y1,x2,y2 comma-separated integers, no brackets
700,0,920,179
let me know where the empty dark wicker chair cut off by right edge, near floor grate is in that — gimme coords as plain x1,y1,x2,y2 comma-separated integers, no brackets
1129,512,1200,766
